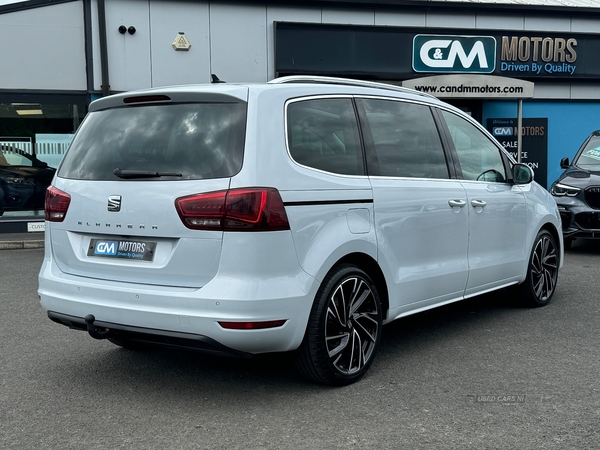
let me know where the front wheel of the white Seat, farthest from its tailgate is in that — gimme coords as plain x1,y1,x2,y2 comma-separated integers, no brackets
519,230,559,307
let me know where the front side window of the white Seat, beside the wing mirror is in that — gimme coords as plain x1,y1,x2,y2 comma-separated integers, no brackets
442,111,506,182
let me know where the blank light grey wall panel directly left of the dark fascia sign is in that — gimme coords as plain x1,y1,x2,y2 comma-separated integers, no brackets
210,3,267,82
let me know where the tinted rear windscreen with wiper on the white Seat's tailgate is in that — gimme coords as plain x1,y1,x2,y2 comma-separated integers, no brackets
58,102,246,180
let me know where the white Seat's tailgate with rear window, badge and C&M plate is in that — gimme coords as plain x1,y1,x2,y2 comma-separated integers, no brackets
49,88,247,287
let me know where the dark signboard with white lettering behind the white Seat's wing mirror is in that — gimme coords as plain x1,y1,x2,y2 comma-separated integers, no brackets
487,118,548,187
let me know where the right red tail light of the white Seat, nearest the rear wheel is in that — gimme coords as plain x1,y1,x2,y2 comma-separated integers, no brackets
175,188,290,231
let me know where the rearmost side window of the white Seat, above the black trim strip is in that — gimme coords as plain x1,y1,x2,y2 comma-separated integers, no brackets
287,98,365,175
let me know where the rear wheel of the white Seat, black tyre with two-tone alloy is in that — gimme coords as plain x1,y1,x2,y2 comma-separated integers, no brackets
296,264,382,386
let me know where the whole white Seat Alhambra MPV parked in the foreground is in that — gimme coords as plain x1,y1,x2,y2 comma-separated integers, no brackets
39,77,563,385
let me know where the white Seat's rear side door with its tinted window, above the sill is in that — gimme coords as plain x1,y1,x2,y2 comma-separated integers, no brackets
359,98,468,316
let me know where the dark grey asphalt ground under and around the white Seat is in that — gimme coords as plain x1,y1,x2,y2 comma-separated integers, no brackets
0,241,600,450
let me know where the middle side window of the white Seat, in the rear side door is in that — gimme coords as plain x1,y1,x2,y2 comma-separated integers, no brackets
362,99,448,178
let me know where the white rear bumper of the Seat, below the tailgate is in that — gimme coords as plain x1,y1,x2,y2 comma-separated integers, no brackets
38,253,319,356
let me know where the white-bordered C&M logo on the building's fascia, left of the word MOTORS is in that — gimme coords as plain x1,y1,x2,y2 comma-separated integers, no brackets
413,34,496,73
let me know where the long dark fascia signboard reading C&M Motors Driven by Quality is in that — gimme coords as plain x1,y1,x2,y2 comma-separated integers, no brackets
275,22,600,80
